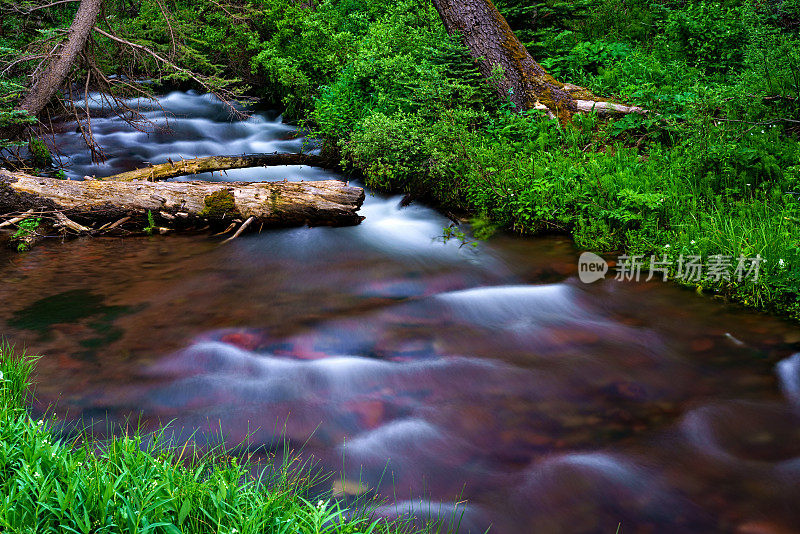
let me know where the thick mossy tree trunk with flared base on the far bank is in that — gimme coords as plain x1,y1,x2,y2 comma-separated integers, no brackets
433,0,644,120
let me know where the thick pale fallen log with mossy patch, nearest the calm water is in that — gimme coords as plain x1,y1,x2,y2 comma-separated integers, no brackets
0,169,364,238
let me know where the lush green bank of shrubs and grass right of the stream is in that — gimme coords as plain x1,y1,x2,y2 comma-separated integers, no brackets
292,0,800,320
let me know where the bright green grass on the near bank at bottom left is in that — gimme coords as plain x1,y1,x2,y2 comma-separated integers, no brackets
0,344,424,534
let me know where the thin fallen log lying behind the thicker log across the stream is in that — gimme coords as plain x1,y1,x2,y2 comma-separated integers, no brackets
103,152,338,182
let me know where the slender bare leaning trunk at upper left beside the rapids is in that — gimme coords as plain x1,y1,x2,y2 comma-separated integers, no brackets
19,0,103,115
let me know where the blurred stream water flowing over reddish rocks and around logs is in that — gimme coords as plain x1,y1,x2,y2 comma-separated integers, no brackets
0,93,800,534
